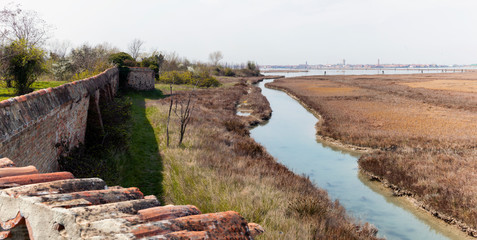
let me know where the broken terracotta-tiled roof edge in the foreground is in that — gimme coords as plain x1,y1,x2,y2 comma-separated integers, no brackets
0,158,263,239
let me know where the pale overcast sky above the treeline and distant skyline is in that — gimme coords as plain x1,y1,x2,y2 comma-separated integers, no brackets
0,0,477,64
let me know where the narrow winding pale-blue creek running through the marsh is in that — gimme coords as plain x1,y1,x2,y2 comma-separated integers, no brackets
251,72,465,239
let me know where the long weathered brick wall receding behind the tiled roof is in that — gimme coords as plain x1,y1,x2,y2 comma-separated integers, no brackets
0,68,119,172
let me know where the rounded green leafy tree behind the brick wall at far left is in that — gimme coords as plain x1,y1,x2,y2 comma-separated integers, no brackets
5,39,45,94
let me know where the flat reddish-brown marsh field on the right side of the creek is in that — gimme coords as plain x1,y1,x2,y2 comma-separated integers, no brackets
270,73,477,235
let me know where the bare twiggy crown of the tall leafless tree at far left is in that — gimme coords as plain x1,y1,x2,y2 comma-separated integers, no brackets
0,5,51,47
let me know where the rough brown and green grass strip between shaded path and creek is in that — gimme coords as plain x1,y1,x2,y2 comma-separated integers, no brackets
147,78,376,239
